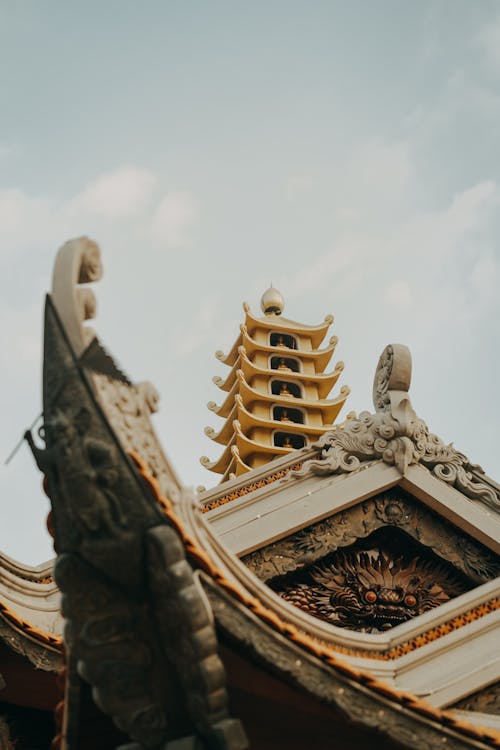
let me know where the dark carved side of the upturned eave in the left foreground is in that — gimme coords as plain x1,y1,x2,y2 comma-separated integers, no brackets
26,298,247,750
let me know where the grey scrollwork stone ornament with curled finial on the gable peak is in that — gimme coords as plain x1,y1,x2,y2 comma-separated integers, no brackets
287,344,500,511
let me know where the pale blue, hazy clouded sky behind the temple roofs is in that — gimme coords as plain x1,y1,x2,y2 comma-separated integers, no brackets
0,0,500,564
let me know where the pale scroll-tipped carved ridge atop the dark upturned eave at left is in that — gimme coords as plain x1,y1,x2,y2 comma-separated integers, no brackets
48,237,180,502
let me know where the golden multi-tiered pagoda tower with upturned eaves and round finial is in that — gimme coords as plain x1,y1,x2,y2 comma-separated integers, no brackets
200,286,349,482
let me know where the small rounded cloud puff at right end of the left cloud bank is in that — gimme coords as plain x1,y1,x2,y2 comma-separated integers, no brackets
151,190,198,249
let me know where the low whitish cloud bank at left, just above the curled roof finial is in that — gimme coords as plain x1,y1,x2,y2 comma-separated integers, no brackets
0,165,198,258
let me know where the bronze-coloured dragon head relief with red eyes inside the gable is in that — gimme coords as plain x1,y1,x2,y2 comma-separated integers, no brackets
279,548,468,633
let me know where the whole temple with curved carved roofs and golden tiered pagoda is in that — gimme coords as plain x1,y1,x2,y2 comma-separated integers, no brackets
0,237,500,750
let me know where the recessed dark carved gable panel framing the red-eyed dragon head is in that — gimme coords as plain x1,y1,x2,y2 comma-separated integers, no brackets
243,488,500,633
